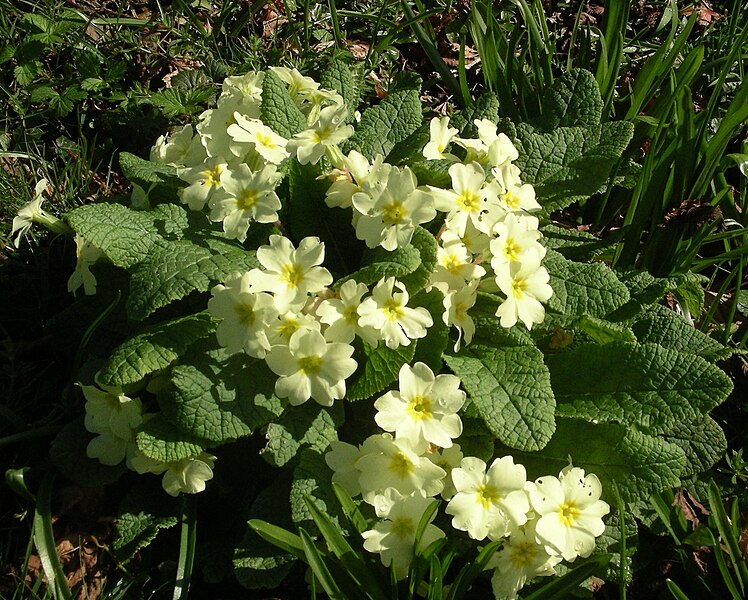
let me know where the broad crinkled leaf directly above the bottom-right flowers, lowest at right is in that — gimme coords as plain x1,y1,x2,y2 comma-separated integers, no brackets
506,418,686,504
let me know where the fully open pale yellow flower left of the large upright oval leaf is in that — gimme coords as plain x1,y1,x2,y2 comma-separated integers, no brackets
374,362,465,453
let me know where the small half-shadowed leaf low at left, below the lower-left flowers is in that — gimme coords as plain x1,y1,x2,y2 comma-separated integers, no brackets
112,477,179,562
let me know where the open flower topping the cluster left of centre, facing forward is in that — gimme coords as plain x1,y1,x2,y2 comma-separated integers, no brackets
250,235,332,313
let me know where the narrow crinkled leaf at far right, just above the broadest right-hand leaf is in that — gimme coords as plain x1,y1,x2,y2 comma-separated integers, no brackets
633,306,730,361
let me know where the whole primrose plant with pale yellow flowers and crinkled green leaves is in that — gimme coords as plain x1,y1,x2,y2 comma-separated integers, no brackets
14,61,730,598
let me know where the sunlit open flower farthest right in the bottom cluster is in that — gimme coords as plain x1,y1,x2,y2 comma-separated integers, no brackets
527,465,610,561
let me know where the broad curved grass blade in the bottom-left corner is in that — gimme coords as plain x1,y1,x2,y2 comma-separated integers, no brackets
33,472,73,600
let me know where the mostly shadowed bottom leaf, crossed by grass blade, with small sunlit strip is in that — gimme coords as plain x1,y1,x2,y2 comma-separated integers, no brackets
233,479,296,589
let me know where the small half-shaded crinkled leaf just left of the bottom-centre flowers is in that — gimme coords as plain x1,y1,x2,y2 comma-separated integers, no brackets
290,448,346,535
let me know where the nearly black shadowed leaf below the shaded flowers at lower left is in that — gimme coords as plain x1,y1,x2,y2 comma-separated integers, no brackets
49,417,127,487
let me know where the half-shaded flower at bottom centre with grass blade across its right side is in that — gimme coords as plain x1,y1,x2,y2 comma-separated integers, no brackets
361,488,444,579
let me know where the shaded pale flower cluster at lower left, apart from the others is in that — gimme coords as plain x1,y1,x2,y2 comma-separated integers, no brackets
81,385,216,496
